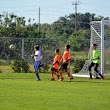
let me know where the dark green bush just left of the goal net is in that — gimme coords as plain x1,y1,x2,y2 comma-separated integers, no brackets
73,59,85,73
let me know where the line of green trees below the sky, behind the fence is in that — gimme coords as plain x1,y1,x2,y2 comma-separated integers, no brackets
0,12,109,51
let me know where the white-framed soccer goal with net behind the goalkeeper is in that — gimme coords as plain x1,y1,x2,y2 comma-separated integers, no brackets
73,20,110,77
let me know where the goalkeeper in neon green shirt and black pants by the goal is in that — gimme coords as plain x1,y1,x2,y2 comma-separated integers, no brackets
88,43,104,79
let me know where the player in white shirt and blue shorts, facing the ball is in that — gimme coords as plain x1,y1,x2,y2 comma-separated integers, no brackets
32,45,42,80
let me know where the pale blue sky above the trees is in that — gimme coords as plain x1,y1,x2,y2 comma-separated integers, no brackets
0,0,110,24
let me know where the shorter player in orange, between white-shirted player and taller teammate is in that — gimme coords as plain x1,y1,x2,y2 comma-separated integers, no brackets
51,49,60,80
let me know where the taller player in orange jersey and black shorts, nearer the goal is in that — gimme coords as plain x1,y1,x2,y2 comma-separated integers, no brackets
59,45,73,81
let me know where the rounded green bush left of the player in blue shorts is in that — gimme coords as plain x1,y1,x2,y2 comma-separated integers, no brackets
11,59,29,73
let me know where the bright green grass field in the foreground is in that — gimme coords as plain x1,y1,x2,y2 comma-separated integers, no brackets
0,73,110,110
